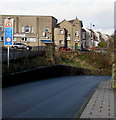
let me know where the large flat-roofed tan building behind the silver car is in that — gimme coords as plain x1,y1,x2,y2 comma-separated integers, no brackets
1,15,57,46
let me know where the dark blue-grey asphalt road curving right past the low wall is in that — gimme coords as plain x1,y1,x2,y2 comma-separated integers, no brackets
2,76,111,118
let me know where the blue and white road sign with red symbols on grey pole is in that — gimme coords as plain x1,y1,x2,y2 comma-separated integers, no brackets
4,18,13,67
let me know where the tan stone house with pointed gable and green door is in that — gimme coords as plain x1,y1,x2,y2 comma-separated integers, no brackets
57,18,83,50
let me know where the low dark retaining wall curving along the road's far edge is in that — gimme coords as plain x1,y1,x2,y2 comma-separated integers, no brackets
2,65,99,87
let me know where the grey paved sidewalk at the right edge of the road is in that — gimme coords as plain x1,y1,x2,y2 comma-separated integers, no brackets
80,81,114,120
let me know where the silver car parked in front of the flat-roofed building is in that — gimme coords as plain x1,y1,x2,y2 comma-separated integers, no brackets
12,43,32,50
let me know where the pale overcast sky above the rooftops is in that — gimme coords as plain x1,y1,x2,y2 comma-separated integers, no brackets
0,0,115,35
